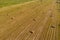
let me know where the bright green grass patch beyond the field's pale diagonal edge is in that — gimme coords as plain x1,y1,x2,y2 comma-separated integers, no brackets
0,0,32,7
